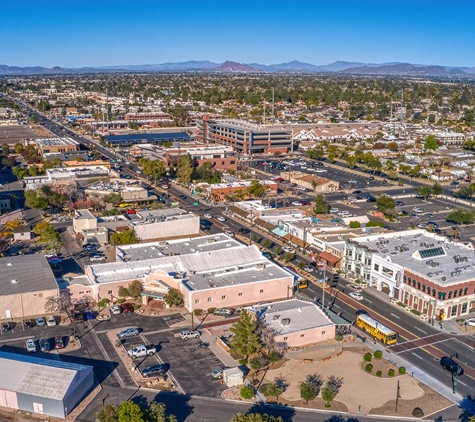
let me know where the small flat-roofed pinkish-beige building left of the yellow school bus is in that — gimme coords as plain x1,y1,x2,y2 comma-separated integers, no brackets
256,299,335,347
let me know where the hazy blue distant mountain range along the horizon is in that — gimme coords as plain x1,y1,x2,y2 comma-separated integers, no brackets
0,60,475,78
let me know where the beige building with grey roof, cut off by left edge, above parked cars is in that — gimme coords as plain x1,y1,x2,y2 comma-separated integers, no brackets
0,254,59,320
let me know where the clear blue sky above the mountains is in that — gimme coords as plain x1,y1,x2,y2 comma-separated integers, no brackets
0,0,475,67
